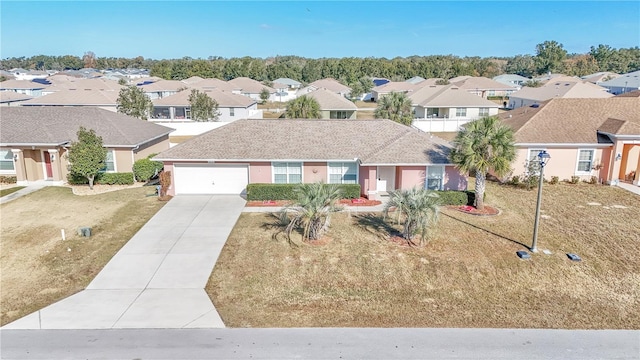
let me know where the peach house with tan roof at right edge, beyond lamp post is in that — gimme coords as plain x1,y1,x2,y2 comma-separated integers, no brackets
500,93,640,185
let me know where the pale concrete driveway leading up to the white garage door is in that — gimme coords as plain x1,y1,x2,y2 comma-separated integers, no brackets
3,195,245,329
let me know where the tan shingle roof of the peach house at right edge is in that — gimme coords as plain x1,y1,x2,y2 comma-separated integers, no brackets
499,97,640,144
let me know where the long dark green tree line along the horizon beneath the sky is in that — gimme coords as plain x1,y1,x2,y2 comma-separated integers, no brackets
0,41,640,85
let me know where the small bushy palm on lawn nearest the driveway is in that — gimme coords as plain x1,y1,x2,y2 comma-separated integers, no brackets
283,183,342,242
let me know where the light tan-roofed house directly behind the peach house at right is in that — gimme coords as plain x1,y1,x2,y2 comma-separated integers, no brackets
508,78,613,109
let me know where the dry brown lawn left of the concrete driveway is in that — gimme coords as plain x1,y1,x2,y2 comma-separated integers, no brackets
0,187,165,325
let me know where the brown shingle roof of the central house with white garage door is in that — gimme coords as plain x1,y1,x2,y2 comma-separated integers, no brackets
156,120,451,165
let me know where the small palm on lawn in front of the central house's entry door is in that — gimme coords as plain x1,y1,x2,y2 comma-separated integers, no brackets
383,187,440,245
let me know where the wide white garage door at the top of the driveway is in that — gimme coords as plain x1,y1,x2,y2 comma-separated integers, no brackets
173,164,249,194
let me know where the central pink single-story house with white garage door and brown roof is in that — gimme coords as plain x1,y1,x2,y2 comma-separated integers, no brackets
155,119,467,198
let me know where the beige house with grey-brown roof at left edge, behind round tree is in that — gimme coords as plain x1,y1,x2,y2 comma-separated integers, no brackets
0,106,173,185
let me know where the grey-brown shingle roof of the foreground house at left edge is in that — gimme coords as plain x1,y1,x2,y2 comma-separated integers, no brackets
0,106,173,147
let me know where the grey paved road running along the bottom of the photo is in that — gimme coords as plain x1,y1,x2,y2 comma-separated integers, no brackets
0,328,640,360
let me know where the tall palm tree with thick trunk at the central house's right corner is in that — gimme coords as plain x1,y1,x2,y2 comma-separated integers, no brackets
450,116,516,210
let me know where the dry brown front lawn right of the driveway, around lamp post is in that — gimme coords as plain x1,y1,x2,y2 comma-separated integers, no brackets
207,183,640,329
